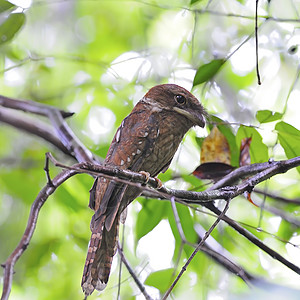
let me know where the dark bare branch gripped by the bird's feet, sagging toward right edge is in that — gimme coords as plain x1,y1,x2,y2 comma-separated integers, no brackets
50,156,300,204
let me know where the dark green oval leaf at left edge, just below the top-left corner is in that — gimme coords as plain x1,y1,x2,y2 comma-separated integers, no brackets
0,13,25,45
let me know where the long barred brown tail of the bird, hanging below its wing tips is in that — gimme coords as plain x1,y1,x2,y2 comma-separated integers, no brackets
81,215,120,296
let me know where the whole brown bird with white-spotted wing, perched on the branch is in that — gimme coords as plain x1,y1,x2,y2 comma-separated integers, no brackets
81,84,206,296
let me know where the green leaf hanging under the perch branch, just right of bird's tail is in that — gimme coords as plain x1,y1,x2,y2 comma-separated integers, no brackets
135,198,169,242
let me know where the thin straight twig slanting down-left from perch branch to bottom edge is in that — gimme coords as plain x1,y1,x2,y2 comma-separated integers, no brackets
162,199,230,300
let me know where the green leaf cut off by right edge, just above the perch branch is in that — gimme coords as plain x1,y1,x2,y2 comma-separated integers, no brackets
275,122,300,173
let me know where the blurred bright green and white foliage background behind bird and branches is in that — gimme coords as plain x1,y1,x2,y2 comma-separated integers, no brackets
0,0,300,300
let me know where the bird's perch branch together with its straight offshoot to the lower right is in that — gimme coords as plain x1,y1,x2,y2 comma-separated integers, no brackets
47,157,300,275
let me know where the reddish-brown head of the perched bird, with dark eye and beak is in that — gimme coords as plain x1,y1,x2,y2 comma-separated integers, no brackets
142,84,207,127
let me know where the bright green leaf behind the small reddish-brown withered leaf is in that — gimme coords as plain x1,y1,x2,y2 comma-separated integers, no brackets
236,126,269,164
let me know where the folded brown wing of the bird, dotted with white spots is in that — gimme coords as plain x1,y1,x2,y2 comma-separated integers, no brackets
92,109,159,231
